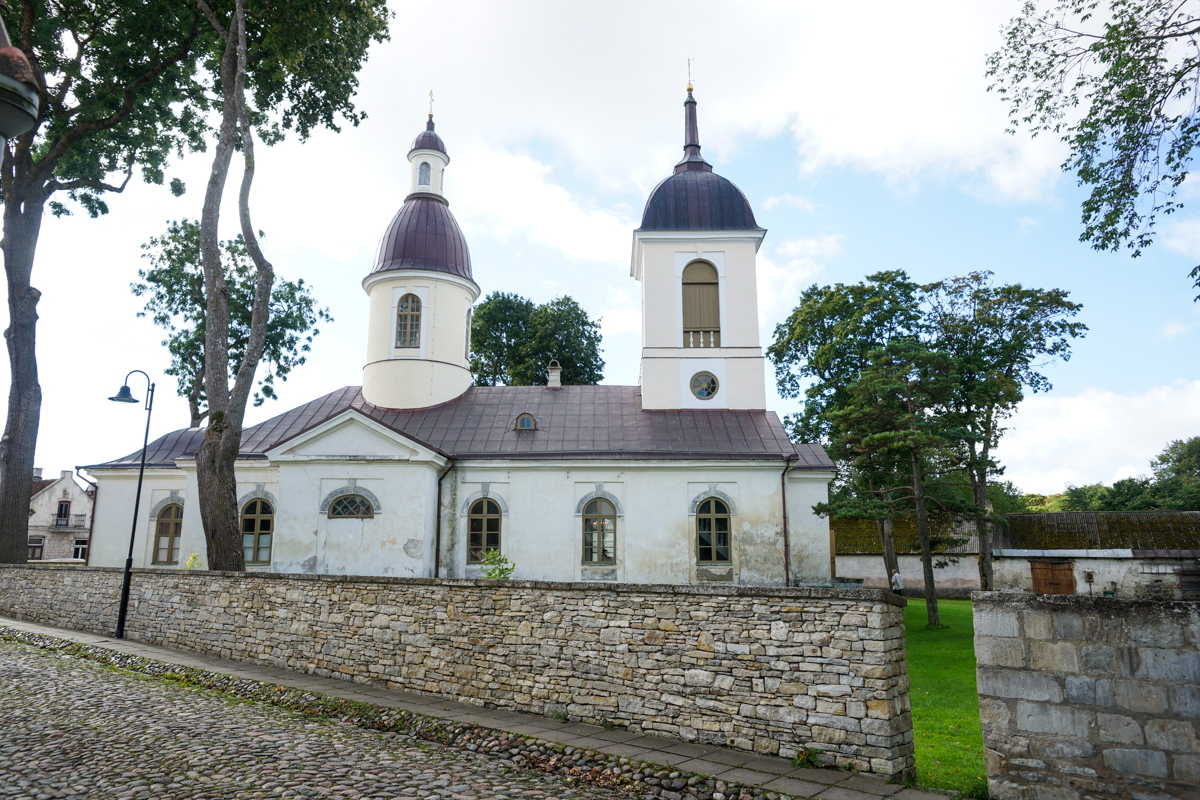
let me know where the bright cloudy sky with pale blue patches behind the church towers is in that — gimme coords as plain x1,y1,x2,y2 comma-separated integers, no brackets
11,0,1200,494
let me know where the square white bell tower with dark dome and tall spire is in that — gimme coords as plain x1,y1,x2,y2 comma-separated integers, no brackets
630,83,767,409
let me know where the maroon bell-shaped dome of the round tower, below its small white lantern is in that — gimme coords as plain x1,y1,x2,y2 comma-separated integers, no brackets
371,192,474,281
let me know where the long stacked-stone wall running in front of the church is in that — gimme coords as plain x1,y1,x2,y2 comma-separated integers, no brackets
0,565,913,775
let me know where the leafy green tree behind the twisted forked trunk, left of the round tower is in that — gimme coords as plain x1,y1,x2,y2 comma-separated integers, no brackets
131,219,334,428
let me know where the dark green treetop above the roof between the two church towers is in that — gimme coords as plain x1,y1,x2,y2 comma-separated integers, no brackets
470,291,604,386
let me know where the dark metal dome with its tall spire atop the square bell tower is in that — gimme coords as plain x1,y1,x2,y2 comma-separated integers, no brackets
638,84,762,230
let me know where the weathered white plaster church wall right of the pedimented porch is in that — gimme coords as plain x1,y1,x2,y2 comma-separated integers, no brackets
442,462,829,585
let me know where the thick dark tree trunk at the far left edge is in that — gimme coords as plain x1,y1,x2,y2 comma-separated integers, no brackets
0,184,43,564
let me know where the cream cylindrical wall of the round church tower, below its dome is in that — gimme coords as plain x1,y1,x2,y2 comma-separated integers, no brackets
362,270,479,408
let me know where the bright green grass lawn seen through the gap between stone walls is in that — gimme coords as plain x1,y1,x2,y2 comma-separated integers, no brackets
905,597,986,796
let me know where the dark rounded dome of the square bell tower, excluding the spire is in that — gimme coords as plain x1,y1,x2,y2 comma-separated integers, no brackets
640,170,760,230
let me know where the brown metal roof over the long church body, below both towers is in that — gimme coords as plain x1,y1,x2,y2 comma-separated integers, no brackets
89,386,834,470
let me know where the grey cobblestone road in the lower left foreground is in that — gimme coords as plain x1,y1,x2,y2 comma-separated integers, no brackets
0,642,628,800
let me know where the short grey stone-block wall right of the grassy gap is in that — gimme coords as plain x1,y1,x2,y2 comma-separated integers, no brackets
972,593,1200,800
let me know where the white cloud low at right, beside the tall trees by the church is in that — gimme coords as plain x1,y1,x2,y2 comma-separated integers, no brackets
997,380,1200,494
